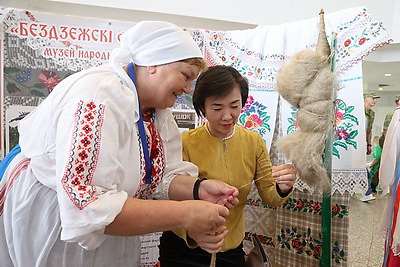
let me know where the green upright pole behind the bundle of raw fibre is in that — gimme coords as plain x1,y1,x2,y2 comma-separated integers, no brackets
320,34,336,267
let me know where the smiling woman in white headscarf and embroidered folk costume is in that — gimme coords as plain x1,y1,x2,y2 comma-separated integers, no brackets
0,21,238,267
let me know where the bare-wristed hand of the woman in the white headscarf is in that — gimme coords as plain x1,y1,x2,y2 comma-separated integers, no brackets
181,200,229,234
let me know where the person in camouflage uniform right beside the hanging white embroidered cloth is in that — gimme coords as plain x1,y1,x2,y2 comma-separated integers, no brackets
360,92,380,202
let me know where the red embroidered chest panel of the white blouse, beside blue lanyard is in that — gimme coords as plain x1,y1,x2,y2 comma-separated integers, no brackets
133,121,165,199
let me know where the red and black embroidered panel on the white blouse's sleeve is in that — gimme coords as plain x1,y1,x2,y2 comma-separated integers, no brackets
61,101,104,210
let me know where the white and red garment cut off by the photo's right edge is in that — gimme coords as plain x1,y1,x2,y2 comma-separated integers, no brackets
379,107,400,267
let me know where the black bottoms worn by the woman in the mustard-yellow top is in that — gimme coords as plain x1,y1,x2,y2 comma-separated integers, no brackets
159,231,245,267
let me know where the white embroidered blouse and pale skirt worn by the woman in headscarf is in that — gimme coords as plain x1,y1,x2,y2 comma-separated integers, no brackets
0,65,197,266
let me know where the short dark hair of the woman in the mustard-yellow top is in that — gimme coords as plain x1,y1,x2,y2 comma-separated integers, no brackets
193,65,249,116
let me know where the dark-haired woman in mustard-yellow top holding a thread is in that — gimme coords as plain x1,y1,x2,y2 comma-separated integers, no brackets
159,66,296,267
